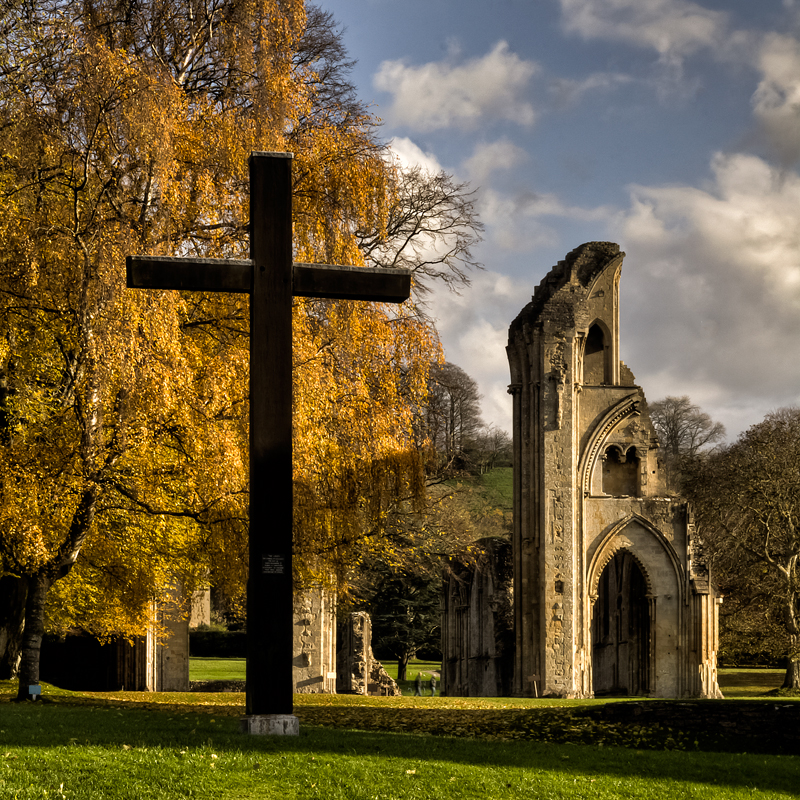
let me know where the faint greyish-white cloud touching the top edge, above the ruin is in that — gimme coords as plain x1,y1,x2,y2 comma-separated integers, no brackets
560,0,727,61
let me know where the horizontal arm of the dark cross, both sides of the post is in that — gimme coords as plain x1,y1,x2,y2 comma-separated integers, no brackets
126,256,411,303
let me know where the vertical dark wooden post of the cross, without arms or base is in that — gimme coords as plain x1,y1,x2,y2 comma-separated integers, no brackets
247,153,293,714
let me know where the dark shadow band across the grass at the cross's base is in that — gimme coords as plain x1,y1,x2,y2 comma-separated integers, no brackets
0,703,800,796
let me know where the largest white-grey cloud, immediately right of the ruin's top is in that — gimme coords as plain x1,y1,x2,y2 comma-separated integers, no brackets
619,154,800,434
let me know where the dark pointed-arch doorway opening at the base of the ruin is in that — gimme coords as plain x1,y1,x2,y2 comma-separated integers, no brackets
592,549,651,696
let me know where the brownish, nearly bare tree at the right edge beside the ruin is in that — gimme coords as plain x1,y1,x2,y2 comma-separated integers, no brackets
684,408,800,690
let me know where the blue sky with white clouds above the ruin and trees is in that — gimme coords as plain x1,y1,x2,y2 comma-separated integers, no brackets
318,0,800,440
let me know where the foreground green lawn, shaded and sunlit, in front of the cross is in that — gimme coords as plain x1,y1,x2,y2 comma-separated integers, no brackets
0,701,800,800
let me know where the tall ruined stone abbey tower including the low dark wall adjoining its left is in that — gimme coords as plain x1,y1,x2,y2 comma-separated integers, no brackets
442,242,720,697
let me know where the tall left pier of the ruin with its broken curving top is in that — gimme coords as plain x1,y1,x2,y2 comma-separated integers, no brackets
508,243,621,696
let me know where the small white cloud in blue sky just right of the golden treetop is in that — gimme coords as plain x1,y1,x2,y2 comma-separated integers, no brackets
374,41,538,131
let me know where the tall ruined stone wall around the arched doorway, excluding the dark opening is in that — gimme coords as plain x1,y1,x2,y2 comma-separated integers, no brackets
508,242,716,696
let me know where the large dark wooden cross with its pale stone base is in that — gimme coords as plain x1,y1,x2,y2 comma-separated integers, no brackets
126,153,411,733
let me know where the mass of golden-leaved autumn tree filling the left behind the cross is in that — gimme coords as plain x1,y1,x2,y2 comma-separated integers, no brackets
0,0,480,697
